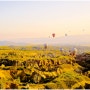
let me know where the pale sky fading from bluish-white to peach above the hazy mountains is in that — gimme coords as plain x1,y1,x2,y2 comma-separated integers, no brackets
0,1,90,40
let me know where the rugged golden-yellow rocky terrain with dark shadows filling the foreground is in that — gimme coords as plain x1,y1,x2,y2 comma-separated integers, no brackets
0,46,90,89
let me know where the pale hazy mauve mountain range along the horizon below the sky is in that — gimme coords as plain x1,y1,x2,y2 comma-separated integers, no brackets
0,35,90,45
